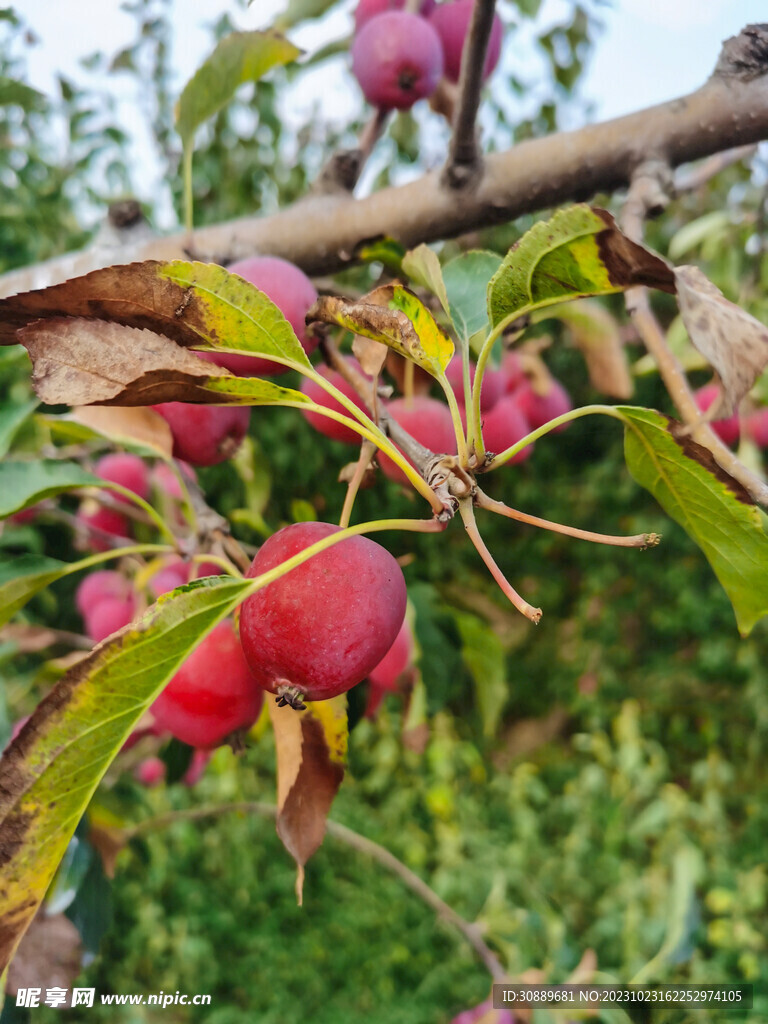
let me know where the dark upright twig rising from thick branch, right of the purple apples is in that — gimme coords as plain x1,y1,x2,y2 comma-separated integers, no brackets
443,0,496,188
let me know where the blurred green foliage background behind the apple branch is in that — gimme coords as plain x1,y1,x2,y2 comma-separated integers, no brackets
0,0,768,1024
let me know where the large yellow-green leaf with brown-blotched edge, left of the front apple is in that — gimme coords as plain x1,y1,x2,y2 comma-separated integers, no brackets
0,577,253,967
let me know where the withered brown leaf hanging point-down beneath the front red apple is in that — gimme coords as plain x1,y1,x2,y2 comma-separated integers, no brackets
268,694,348,905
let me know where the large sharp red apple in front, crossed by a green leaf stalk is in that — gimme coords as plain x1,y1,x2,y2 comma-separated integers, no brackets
240,522,406,700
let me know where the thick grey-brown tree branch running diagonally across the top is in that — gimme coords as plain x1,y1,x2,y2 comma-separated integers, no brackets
0,26,768,295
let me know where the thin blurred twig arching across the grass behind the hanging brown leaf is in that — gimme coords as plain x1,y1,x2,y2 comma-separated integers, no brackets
122,801,508,981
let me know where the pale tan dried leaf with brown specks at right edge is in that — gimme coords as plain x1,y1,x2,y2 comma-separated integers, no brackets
675,266,768,419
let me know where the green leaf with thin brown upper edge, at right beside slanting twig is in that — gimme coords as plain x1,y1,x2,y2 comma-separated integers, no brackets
616,407,768,636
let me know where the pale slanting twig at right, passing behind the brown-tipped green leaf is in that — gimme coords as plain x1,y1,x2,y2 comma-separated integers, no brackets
622,165,768,506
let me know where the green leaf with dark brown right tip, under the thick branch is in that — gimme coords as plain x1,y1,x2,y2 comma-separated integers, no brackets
487,204,676,328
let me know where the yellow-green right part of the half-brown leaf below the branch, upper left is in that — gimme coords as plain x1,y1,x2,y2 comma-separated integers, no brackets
157,260,309,369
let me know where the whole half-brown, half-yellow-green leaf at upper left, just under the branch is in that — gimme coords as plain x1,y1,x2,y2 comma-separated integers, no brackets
0,260,309,375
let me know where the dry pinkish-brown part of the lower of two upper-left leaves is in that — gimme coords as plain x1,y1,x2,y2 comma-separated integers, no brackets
17,316,227,406
